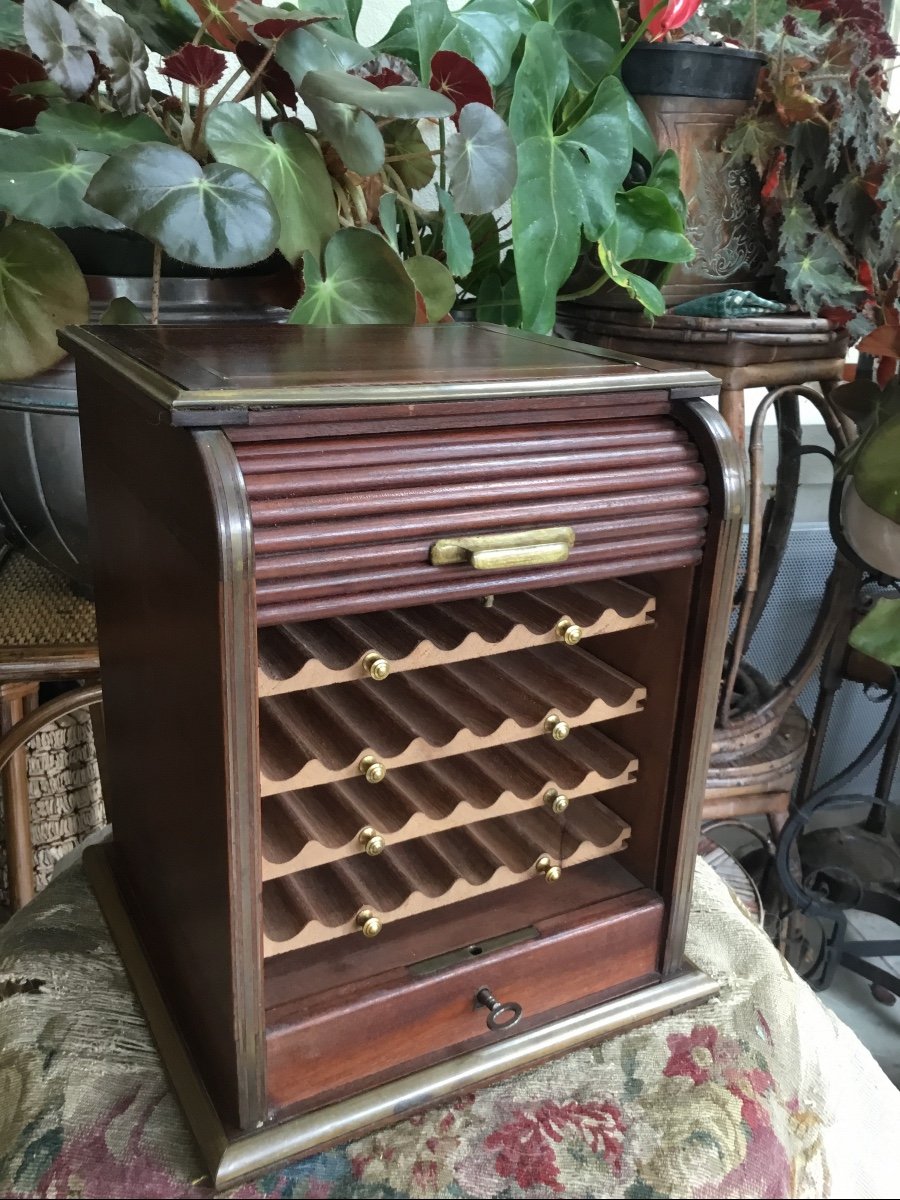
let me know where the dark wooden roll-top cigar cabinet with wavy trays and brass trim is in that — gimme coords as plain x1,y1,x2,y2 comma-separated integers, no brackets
62,324,742,1187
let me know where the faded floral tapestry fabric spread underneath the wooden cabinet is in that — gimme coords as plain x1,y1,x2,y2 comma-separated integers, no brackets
0,863,900,1200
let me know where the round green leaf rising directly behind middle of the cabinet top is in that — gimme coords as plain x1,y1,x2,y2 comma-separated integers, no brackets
288,229,415,325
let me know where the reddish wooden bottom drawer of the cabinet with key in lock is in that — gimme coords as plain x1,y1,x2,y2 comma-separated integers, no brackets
266,890,664,1109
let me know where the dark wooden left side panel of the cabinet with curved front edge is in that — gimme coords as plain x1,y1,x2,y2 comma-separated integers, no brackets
78,361,264,1128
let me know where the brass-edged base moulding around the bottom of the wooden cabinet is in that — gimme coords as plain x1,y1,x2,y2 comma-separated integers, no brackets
84,846,720,1190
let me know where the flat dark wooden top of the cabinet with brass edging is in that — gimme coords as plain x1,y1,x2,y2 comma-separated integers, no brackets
60,323,718,409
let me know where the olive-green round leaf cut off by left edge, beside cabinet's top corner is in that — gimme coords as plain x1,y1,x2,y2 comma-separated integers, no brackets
0,221,90,379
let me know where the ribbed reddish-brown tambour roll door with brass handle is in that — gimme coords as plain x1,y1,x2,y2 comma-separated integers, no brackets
234,416,707,625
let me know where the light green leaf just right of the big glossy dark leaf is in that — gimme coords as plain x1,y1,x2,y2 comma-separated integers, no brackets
205,103,338,263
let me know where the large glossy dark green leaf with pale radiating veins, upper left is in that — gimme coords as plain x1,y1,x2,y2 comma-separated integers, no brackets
88,145,281,268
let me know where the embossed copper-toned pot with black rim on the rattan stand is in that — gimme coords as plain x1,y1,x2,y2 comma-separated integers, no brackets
618,42,772,307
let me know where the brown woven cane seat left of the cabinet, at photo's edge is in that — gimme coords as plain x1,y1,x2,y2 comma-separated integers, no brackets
0,551,97,648
